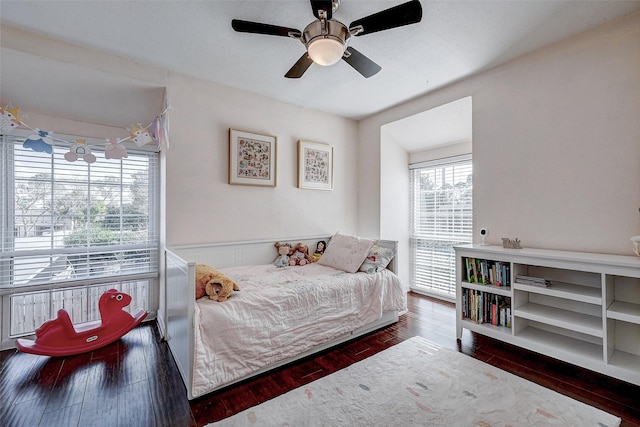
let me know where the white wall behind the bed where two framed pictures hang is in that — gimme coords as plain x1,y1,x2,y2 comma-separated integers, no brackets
167,76,357,246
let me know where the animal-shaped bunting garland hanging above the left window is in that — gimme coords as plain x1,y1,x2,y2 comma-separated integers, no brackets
0,105,170,163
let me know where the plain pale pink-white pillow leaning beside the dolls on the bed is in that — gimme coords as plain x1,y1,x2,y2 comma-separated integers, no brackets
318,232,377,273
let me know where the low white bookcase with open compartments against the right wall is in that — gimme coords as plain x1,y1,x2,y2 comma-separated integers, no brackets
455,245,640,385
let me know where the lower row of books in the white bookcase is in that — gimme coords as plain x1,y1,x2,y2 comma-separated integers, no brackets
462,288,511,328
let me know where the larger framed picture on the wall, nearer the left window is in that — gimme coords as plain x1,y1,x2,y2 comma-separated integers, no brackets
229,129,277,187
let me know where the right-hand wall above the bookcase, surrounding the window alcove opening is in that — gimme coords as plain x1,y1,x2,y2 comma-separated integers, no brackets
358,13,640,255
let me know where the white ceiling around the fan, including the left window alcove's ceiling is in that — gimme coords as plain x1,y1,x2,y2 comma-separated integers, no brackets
0,0,640,146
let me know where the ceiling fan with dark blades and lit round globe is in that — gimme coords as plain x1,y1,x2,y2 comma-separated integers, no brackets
231,0,422,79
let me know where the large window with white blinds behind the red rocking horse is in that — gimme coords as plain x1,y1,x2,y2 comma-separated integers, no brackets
0,132,159,340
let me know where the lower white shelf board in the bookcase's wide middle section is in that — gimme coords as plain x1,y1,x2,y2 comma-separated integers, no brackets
513,303,602,338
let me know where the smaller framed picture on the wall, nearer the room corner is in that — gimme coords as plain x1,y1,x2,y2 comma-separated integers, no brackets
298,141,333,190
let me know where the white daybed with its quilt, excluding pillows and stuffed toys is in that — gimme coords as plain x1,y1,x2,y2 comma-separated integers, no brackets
165,237,406,399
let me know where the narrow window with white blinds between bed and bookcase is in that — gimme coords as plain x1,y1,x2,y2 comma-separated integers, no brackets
410,155,473,299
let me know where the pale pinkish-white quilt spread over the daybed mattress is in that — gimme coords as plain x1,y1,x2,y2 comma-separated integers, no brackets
192,263,406,395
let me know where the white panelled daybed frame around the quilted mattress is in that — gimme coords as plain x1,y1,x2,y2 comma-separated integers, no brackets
163,236,398,400
